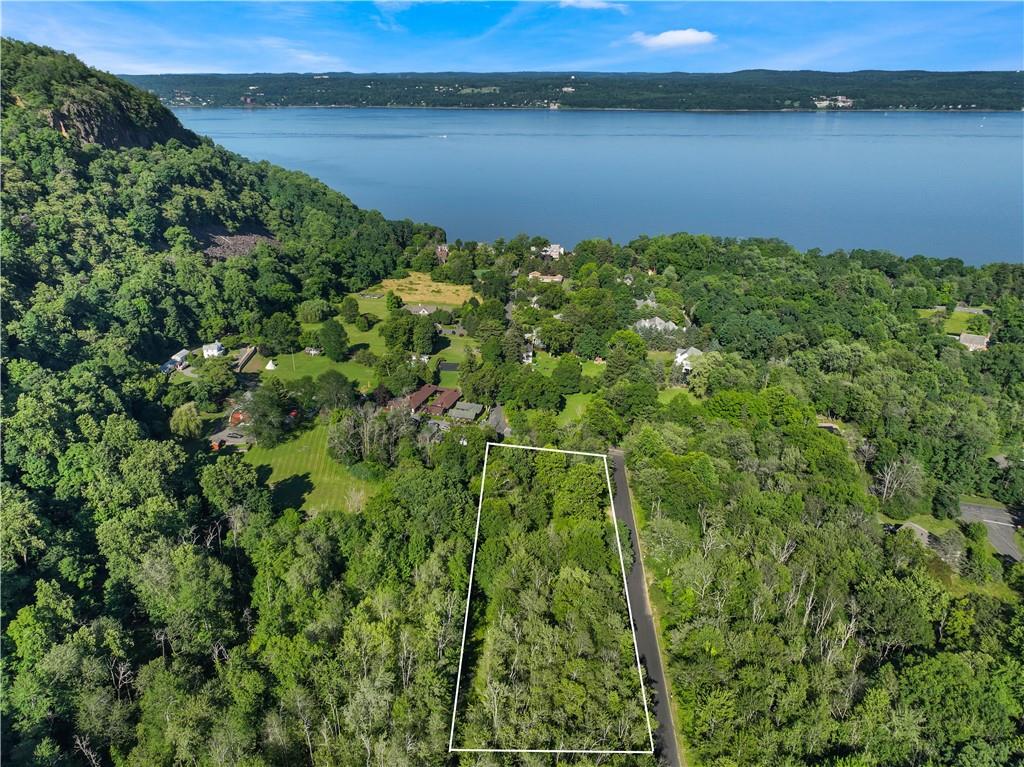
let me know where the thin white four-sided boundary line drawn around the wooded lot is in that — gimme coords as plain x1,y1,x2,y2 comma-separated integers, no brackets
449,442,654,754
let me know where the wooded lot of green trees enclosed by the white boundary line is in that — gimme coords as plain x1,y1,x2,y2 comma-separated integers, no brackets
450,442,653,755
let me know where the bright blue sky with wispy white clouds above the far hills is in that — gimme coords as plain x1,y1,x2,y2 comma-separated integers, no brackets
0,0,1024,74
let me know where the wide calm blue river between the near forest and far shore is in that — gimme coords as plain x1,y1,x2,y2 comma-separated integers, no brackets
177,109,1024,264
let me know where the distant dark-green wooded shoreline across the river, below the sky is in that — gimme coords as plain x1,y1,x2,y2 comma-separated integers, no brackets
125,70,1024,111
